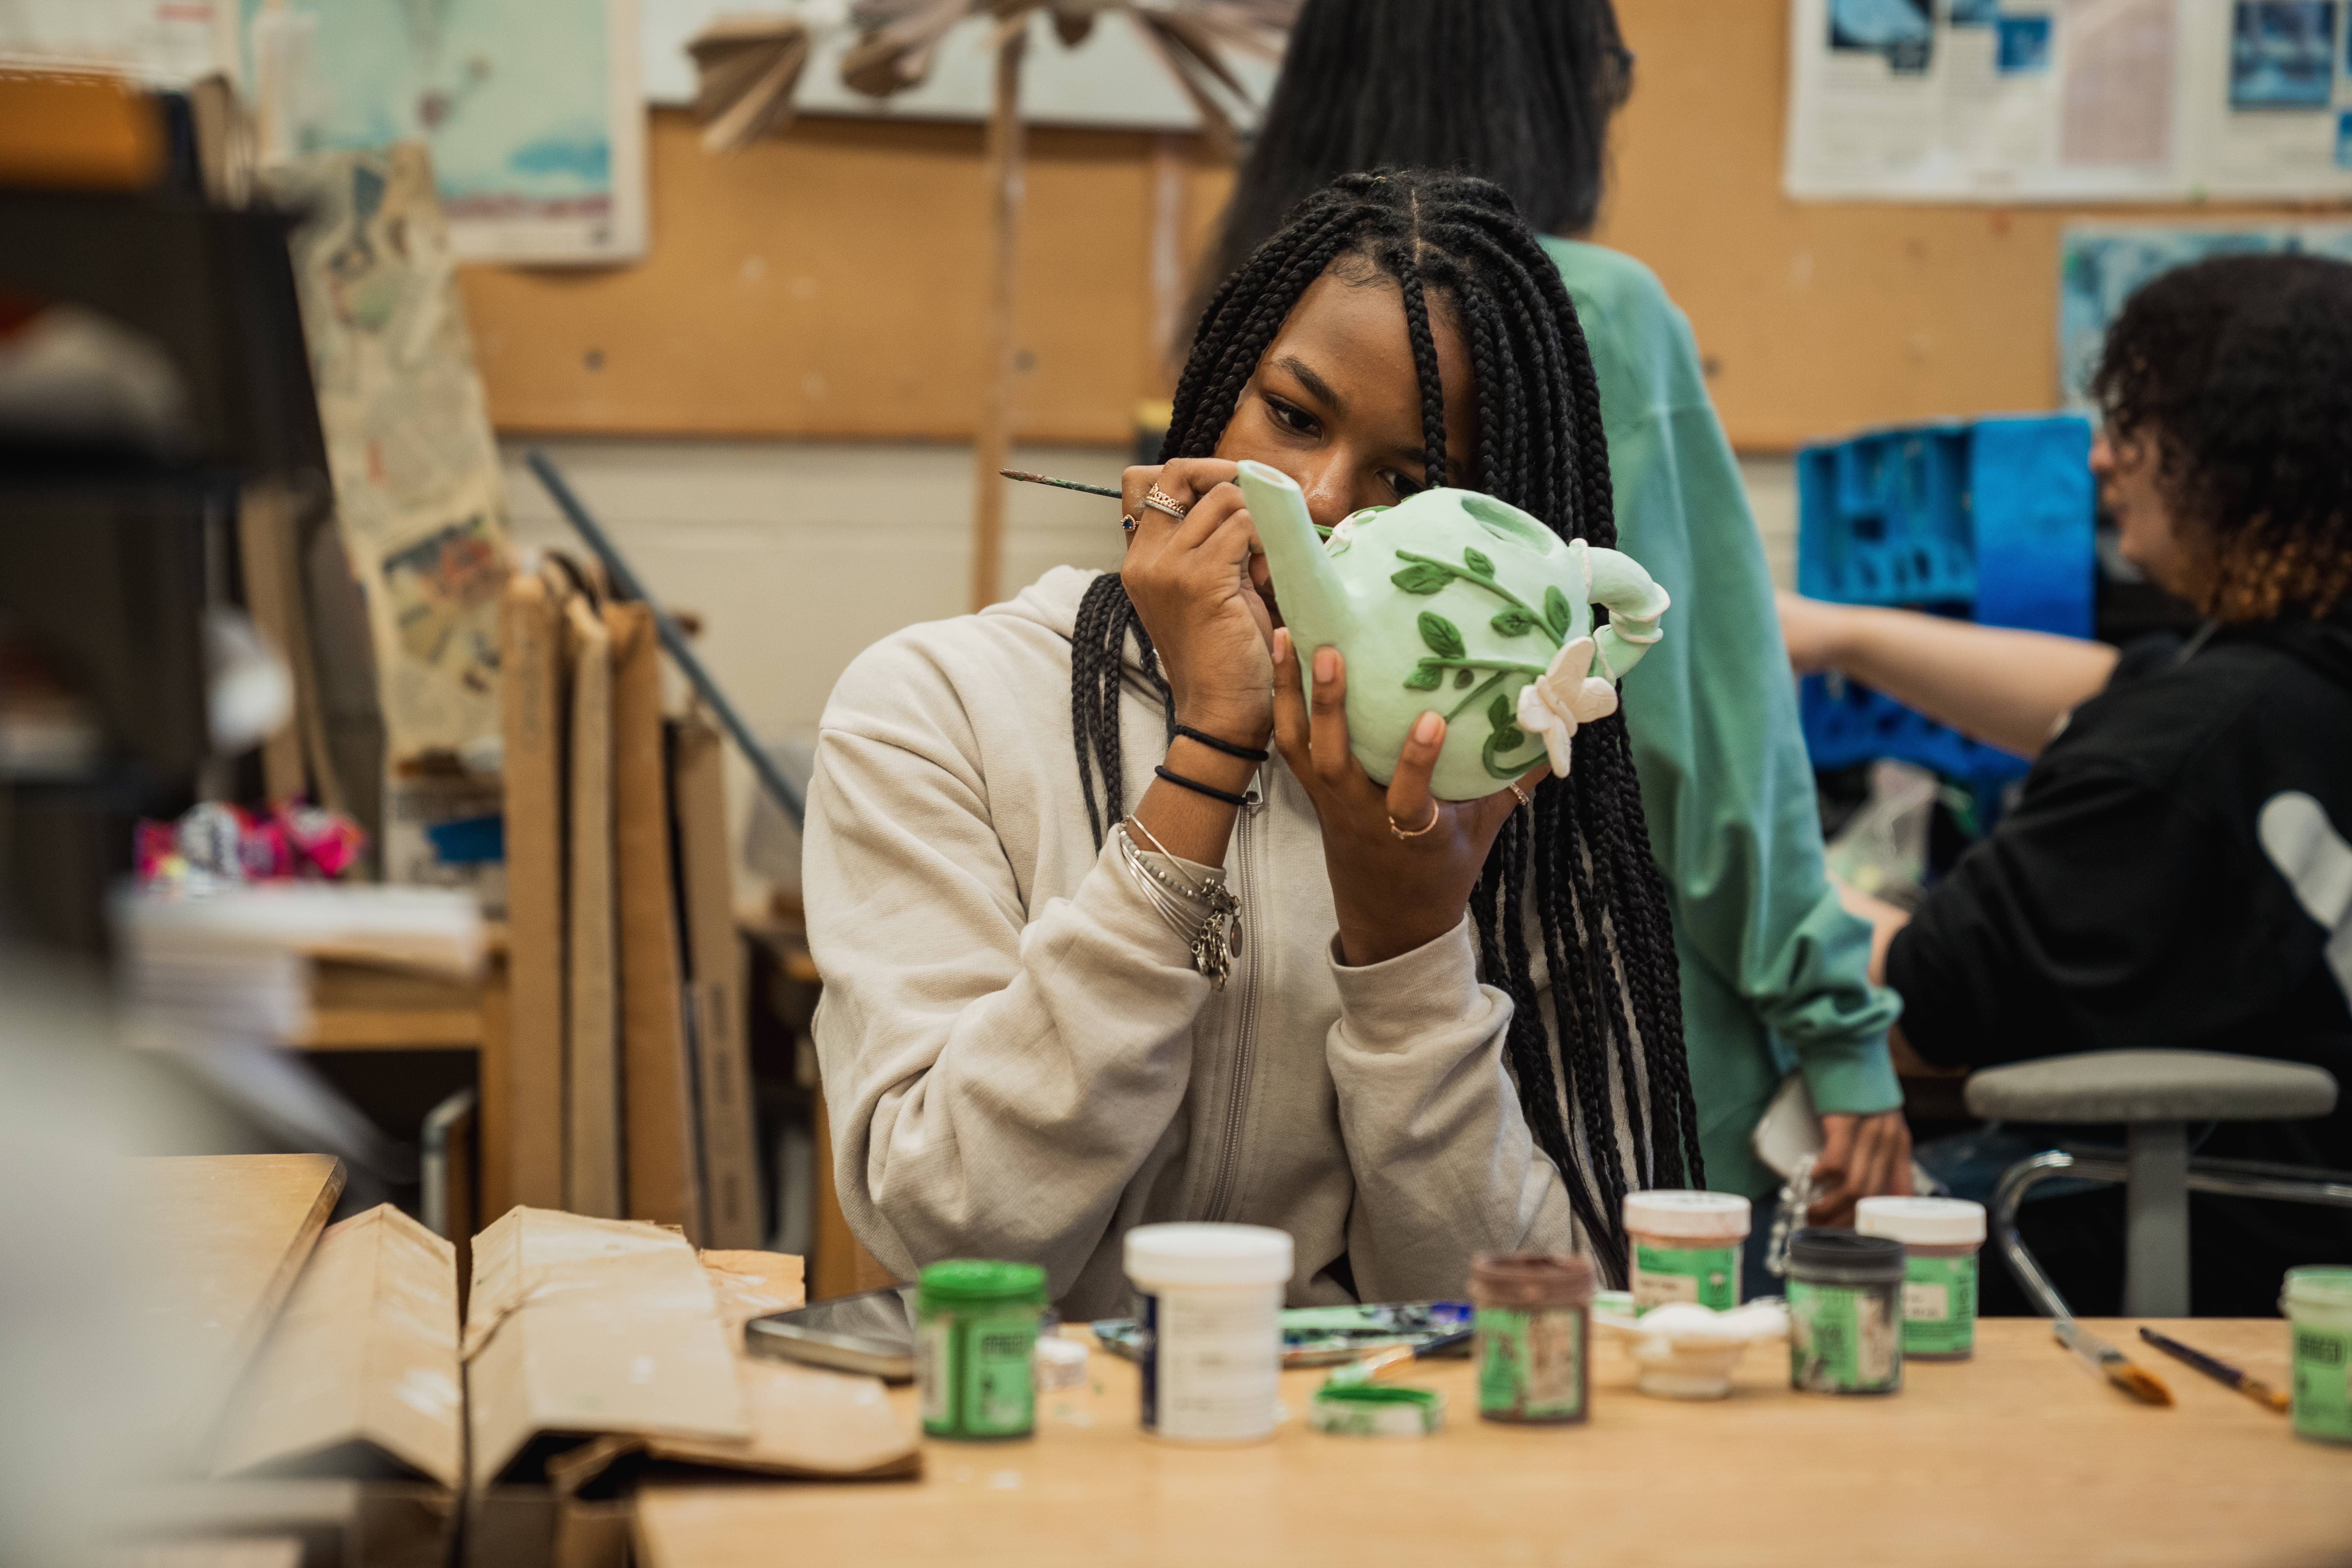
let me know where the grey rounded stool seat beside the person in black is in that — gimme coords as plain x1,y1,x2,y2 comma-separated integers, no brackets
1969,1051,2336,1121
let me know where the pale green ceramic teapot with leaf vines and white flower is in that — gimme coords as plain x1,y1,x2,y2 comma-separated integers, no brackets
1239,463,1668,799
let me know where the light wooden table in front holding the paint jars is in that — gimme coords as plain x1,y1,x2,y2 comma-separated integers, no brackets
637,1319,2352,1568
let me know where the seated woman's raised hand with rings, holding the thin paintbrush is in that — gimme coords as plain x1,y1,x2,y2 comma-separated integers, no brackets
1120,458,1275,745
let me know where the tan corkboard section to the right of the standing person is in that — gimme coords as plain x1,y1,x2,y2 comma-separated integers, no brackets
1592,0,2333,451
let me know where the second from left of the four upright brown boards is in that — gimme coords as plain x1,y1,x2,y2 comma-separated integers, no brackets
565,595,626,1220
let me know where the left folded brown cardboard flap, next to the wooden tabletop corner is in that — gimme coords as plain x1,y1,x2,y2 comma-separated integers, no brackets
212,1204,463,1488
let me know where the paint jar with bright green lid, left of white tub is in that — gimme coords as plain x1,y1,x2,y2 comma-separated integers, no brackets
915,1258,1044,1439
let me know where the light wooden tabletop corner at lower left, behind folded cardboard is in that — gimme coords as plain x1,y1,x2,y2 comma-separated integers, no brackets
125,1154,343,1469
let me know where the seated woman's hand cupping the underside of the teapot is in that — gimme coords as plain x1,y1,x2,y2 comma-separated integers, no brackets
1275,630,1545,966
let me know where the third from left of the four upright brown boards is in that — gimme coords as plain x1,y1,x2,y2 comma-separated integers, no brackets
604,604,703,1243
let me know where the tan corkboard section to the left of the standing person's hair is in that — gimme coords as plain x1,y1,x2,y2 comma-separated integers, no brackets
466,110,1228,442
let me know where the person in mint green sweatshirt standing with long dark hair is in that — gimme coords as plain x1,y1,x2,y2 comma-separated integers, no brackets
1202,0,1910,1222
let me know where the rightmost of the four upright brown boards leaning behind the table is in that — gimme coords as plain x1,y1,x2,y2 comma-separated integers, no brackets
670,715,765,1248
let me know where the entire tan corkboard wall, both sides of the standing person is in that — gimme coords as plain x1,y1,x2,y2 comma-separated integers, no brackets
466,0,2333,451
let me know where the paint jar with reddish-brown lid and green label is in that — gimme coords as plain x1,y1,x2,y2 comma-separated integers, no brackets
1470,1253,1595,1427
